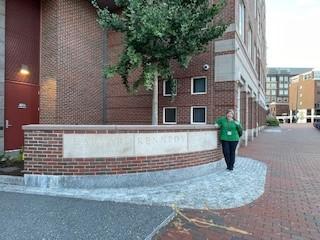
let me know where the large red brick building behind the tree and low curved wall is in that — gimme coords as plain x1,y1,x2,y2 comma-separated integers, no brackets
1,0,266,149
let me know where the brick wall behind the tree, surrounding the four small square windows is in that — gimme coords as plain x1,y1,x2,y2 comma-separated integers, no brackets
106,1,237,124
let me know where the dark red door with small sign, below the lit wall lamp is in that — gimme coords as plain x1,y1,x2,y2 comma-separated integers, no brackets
4,81,39,150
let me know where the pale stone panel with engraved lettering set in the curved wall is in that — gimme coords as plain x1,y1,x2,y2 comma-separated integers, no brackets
63,131,217,158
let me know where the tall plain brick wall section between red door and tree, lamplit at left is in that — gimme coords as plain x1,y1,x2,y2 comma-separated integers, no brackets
40,0,102,124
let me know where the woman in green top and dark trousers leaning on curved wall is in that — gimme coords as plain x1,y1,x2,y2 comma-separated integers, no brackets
216,109,242,171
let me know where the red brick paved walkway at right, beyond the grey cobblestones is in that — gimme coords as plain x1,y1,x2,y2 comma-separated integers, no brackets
155,124,320,240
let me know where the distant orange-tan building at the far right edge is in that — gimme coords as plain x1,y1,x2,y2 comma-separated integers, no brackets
289,70,320,123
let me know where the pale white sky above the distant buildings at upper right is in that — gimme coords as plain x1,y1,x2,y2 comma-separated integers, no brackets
266,0,320,69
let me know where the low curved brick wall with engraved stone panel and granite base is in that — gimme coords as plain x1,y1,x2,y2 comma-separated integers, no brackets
23,125,222,188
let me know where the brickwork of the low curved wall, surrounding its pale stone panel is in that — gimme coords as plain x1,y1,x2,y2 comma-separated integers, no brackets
24,126,222,175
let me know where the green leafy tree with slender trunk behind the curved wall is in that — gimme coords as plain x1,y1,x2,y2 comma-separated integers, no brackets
92,0,227,125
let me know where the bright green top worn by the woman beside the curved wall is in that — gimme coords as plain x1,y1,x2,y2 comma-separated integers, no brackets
216,116,242,141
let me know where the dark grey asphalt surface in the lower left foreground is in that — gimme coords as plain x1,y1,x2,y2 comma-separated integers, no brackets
0,189,172,240
